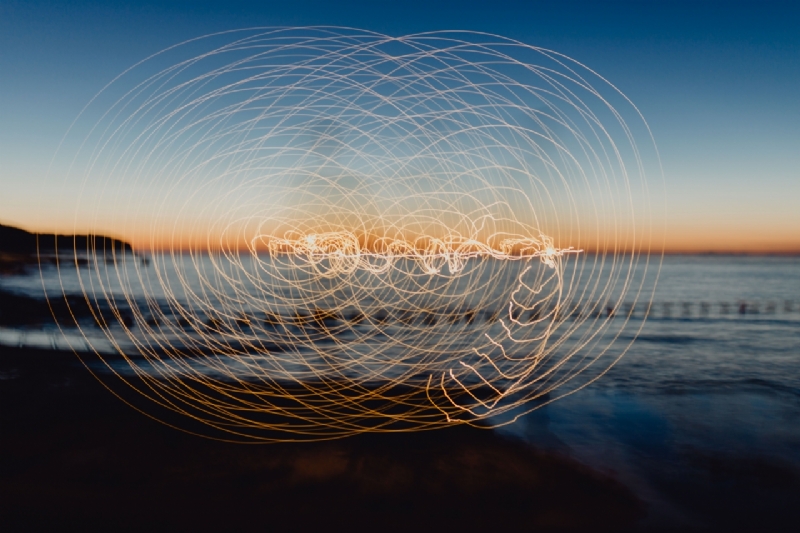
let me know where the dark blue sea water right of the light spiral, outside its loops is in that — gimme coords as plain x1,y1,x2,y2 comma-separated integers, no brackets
500,256,800,531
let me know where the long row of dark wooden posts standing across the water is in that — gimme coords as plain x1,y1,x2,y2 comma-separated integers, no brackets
128,300,800,329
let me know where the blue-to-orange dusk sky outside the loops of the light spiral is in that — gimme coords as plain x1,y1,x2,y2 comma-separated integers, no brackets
0,0,800,252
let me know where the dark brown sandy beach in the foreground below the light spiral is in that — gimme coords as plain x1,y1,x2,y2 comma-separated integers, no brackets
0,348,646,532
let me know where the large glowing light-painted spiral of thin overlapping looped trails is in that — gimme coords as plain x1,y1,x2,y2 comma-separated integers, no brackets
46,27,660,442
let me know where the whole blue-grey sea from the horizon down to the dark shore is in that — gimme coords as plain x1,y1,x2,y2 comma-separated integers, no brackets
0,255,800,528
